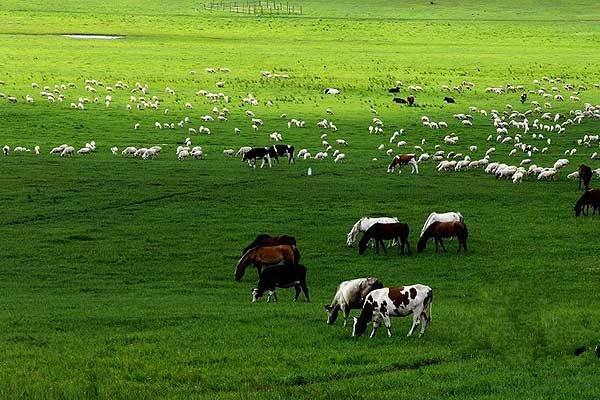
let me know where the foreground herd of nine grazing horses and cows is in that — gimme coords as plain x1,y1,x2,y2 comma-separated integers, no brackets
235,212,467,337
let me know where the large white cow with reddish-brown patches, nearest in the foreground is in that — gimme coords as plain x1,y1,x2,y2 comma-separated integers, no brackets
352,285,433,337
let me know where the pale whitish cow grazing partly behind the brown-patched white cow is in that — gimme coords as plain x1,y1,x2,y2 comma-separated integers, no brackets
325,278,383,326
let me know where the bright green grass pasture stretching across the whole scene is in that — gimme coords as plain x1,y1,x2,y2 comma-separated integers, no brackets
0,0,600,399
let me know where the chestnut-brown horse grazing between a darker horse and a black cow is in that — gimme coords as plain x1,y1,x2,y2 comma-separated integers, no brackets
235,245,300,281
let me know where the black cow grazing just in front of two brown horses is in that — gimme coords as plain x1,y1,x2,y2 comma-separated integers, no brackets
252,264,310,303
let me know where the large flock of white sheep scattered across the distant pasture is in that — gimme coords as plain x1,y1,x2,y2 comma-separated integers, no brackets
0,73,600,183
